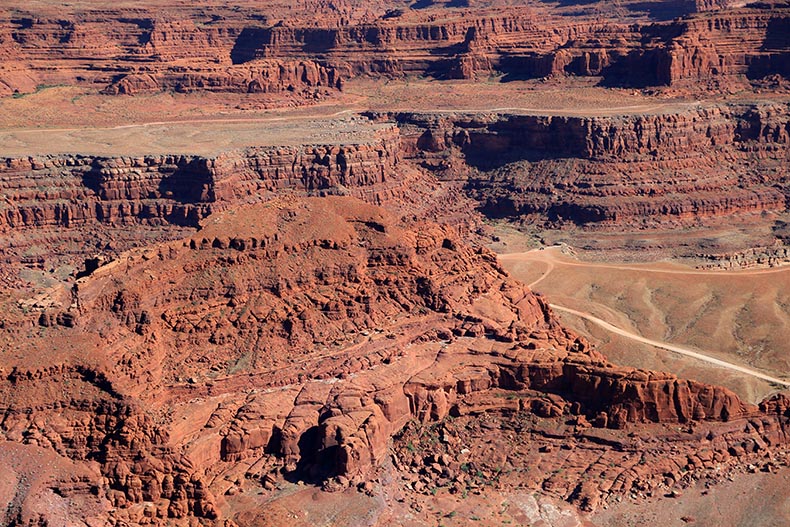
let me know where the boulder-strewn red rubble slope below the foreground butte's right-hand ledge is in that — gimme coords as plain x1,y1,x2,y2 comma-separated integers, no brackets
394,393,787,512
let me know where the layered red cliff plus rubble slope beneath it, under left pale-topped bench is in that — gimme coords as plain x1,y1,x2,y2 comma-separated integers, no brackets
0,126,408,284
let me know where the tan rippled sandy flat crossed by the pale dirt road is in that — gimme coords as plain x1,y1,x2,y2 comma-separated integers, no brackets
500,248,790,402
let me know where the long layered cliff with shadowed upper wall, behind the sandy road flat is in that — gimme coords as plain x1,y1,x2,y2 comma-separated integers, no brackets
395,104,790,227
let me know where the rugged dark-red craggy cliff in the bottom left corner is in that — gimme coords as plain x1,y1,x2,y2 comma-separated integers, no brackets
0,364,217,524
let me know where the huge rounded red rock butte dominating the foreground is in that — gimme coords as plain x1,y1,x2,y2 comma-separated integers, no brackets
0,197,788,523
